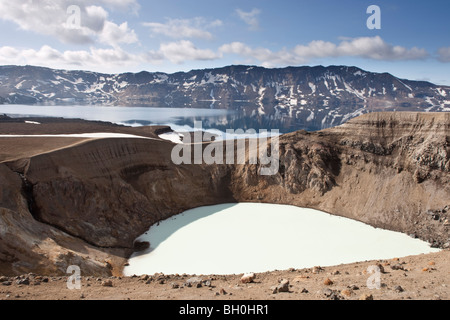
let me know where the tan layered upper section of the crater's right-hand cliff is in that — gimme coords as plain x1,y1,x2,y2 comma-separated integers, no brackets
330,112,450,179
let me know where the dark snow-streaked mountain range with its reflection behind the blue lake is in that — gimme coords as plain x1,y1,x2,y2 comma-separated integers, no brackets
0,66,450,130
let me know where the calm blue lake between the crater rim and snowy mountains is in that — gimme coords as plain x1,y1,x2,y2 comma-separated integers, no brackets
0,105,294,133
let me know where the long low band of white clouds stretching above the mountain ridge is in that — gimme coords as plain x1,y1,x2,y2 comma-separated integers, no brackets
0,35,434,72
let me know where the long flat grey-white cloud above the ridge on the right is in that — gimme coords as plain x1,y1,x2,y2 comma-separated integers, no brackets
219,36,429,67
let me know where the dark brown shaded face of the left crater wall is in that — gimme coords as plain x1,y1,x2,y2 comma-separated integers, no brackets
7,139,233,249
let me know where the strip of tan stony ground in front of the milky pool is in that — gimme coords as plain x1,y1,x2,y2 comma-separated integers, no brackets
0,250,450,301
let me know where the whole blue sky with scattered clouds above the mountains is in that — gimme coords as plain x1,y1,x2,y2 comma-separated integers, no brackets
0,0,450,85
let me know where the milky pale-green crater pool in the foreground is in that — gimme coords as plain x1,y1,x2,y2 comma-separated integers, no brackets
124,203,439,276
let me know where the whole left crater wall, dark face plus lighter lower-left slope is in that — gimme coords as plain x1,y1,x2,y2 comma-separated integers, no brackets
0,135,235,275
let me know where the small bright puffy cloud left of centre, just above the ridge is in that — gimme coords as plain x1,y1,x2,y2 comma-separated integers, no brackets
159,40,220,64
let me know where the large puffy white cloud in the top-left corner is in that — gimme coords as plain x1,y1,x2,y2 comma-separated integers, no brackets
0,0,138,45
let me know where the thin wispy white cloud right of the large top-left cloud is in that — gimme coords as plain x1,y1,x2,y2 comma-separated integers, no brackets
143,17,223,40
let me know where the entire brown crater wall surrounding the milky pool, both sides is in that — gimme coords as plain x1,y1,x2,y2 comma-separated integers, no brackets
0,113,450,275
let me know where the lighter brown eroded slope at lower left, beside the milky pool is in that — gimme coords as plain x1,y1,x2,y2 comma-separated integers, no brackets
0,164,118,275
